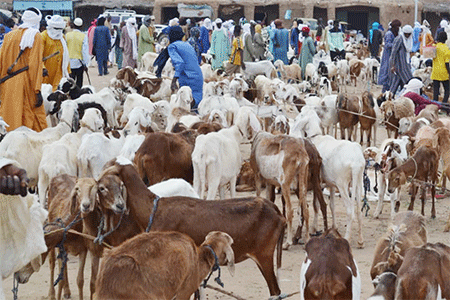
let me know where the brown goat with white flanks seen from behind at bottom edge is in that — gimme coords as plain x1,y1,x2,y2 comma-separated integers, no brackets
300,229,361,300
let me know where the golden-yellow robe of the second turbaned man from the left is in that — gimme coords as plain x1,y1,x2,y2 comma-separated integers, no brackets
41,30,70,91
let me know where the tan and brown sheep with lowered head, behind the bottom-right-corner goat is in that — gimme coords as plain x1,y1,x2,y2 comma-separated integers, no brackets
370,211,427,280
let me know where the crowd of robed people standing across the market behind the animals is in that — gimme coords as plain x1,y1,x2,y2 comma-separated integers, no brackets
0,8,450,131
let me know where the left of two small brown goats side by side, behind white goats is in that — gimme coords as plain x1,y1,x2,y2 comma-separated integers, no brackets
337,94,361,141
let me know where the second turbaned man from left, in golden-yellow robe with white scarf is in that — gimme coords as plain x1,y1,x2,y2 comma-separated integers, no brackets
42,15,70,91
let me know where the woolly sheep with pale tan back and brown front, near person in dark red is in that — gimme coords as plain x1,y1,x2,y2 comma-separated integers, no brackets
380,97,414,138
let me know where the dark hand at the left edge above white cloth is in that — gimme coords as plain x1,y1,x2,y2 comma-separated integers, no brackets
0,164,30,197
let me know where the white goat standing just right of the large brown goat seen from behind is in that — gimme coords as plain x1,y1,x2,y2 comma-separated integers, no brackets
290,110,365,247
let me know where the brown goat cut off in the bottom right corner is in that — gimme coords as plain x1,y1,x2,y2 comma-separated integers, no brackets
395,243,450,300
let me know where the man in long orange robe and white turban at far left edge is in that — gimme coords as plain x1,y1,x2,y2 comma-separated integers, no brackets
0,8,47,131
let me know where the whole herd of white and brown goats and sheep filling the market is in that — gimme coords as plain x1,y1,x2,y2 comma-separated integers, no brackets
0,39,450,300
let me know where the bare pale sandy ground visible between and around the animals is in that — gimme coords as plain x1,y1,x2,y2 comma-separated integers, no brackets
3,63,450,300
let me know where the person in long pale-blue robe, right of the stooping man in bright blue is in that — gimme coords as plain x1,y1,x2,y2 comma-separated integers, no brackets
209,18,231,70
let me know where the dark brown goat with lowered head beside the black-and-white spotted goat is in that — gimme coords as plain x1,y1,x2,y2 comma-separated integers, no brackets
388,146,439,218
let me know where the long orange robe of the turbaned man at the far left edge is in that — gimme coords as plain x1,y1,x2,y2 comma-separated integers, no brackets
0,29,47,131
